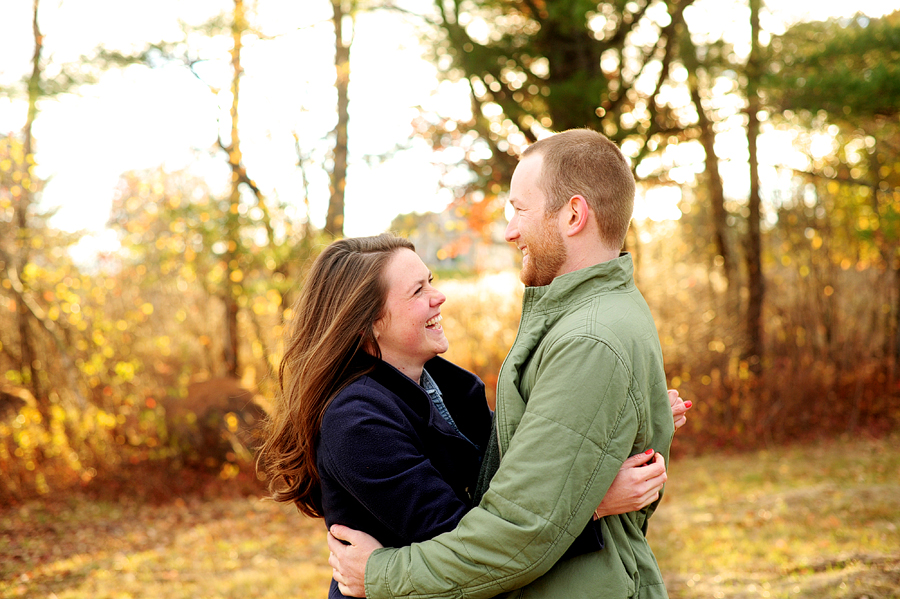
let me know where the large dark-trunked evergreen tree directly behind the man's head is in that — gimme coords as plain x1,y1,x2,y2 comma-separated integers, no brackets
419,0,692,202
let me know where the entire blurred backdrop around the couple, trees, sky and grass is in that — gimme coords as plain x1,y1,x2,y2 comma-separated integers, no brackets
0,0,900,599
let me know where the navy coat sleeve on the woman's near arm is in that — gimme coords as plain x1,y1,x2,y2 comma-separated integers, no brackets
319,389,468,540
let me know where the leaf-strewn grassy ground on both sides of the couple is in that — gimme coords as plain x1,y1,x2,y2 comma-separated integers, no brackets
0,435,900,599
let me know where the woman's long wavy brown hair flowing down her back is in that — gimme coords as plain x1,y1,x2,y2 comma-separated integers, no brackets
257,233,415,517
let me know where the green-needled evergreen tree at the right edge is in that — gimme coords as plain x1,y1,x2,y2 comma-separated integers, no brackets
763,11,900,372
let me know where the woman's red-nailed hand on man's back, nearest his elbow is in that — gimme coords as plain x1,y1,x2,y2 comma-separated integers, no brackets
594,449,666,519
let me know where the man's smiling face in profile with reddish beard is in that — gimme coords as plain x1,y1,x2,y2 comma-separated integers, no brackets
506,154,566,287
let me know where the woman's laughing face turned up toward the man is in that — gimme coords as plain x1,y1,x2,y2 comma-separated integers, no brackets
374,248,449,381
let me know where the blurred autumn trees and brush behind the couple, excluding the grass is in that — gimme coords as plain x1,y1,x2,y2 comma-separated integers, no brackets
0,0,900,596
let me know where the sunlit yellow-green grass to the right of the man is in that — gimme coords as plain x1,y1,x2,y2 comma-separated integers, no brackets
649,434,900,599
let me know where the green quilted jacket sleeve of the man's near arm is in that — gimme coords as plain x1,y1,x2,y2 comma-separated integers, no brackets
366,336,639,599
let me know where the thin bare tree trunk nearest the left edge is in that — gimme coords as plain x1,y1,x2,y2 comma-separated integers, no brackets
15,0,42,410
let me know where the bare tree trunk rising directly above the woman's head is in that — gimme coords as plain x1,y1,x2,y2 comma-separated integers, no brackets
325,0,353,238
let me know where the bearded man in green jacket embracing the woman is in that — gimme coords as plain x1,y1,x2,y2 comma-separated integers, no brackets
329,130,674,599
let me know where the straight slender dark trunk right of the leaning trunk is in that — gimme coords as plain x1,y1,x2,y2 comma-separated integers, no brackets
746,0,765,374
